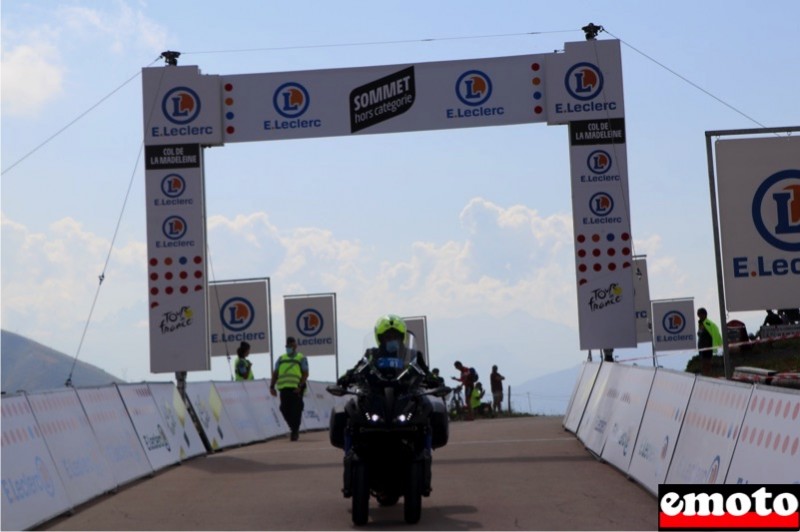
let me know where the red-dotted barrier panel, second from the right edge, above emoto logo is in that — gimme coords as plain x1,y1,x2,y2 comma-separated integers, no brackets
666,377,753,484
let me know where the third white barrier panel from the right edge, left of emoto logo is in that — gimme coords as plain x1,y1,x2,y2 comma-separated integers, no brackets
628,368,695,495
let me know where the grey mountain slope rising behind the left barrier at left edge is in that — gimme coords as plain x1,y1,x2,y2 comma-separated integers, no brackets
0,330,125,393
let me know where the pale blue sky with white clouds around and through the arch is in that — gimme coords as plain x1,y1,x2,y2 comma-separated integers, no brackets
0,0,800,386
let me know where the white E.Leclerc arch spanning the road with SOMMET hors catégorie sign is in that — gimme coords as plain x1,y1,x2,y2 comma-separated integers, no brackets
142,36,637,373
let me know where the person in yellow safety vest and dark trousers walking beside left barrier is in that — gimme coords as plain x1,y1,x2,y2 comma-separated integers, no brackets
269,336,308,441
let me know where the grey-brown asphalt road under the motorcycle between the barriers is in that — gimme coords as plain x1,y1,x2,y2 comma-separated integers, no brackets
41,417,657,531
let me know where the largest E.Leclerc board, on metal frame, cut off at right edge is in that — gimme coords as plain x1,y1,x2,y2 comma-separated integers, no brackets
716,136,800,311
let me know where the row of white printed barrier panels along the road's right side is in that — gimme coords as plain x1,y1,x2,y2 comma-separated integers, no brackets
563,362,800,495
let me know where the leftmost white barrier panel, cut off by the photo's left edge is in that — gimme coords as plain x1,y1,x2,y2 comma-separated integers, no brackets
0,395,71,530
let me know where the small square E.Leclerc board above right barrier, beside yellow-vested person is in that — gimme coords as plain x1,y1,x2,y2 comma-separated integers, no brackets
652,298,697,352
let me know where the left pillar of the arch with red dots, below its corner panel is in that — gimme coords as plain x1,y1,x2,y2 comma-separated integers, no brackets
145,144,211,373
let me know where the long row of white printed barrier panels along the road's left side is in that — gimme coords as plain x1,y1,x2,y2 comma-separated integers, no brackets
0,380,336,530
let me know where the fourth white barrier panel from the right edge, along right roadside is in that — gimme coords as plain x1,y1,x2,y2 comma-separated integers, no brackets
601,364,656,472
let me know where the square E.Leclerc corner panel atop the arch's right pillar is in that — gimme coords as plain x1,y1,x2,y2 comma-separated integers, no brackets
545,40,625,125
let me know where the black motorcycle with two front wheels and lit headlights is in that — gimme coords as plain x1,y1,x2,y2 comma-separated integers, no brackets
327,334,451,526
